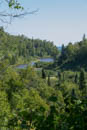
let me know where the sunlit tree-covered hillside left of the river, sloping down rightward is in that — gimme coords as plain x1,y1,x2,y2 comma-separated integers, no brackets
0,27,59,64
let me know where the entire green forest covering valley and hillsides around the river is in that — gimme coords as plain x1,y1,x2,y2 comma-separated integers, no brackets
0,27,87,130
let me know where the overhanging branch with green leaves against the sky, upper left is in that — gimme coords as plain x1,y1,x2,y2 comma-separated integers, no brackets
0,0,38,24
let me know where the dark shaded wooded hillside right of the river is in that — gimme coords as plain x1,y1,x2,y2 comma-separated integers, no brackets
58,36,87,70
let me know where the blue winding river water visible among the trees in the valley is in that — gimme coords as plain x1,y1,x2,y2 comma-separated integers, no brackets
17,58,54,69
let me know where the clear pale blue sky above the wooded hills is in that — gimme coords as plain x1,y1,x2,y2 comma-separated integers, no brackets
6,0,87,46
